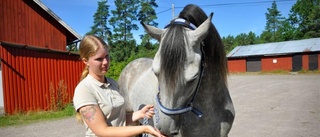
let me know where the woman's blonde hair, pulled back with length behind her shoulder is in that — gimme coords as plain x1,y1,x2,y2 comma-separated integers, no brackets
76,35,110,124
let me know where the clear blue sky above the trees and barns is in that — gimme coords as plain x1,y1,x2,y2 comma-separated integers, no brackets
41,0,296,43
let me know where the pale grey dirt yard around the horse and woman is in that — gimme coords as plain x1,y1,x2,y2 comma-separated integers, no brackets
0,75,320,137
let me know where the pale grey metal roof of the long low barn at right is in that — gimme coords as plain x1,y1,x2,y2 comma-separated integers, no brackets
227,38,320,58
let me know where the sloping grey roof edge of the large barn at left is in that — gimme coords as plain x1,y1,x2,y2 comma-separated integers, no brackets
33,0,81,39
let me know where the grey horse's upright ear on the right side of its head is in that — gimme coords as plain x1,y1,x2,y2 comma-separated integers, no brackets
192,12,213,43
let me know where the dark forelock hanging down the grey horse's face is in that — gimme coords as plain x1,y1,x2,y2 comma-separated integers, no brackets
160,24,187,89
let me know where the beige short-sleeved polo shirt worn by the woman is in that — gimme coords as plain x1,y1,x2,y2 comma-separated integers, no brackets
73,74,126,136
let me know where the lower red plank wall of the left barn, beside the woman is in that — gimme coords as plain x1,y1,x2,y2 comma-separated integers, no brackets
0,43,84,114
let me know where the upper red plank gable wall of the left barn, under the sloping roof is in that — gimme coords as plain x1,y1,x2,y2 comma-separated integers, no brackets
0,0,67,50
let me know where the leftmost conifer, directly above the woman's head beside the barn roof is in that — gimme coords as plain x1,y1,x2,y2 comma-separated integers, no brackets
87,0,111,41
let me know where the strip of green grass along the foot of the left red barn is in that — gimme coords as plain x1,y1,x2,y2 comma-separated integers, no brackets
0,105,75,127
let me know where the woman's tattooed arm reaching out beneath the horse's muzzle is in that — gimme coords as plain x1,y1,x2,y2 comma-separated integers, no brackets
79,105,162,137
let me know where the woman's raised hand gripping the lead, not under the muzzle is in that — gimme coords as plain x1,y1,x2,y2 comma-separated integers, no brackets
132,105,154,121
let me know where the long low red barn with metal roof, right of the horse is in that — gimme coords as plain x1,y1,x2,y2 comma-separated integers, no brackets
227,38,320,73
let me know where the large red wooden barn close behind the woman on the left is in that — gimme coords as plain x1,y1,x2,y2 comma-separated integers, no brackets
0,0,83,114
